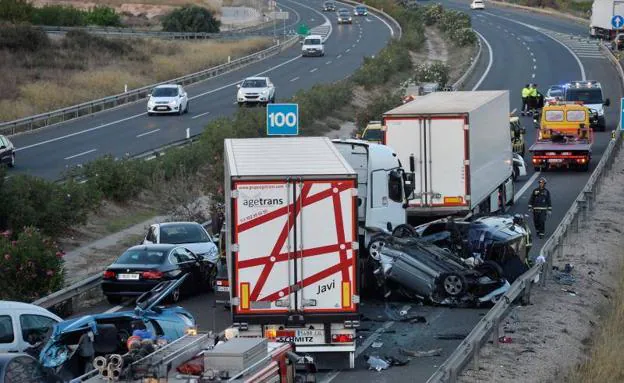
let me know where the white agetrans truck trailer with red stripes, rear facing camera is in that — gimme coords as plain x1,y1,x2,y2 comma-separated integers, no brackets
224,137,359,368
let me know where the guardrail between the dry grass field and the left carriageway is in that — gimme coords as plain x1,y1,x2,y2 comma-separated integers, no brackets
0,36,298,136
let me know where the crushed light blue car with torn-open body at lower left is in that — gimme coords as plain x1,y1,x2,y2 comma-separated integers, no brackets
39,274,195,380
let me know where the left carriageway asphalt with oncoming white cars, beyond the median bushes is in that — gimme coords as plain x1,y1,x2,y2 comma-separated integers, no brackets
13,0,390,179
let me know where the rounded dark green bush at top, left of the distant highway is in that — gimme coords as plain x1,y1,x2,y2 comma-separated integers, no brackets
162,5,221,33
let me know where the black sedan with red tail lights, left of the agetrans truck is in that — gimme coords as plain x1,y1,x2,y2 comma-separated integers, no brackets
102,244,215,304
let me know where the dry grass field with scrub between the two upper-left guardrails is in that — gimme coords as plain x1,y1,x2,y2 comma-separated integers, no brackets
0,26,271,121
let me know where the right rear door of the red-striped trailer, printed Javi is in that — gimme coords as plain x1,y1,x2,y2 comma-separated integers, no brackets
295,179,358,321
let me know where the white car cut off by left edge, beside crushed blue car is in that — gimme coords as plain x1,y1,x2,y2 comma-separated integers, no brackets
0,301,63,352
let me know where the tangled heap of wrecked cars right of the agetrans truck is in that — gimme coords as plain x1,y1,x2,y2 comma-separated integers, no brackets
369,215,531,305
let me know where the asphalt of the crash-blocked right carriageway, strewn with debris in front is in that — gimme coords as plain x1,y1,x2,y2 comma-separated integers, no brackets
52,1,622,382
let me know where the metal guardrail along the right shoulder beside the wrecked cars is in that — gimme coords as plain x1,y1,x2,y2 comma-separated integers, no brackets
427,42,624,383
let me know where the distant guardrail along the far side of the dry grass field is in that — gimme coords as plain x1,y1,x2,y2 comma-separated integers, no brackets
33,21,273,40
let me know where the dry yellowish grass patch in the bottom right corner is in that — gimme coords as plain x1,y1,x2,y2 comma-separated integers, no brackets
566,266,624,383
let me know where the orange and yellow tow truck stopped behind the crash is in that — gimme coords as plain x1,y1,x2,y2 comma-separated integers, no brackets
529,101,598,171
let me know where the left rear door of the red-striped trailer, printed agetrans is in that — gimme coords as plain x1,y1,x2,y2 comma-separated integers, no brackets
231,181,300,315
